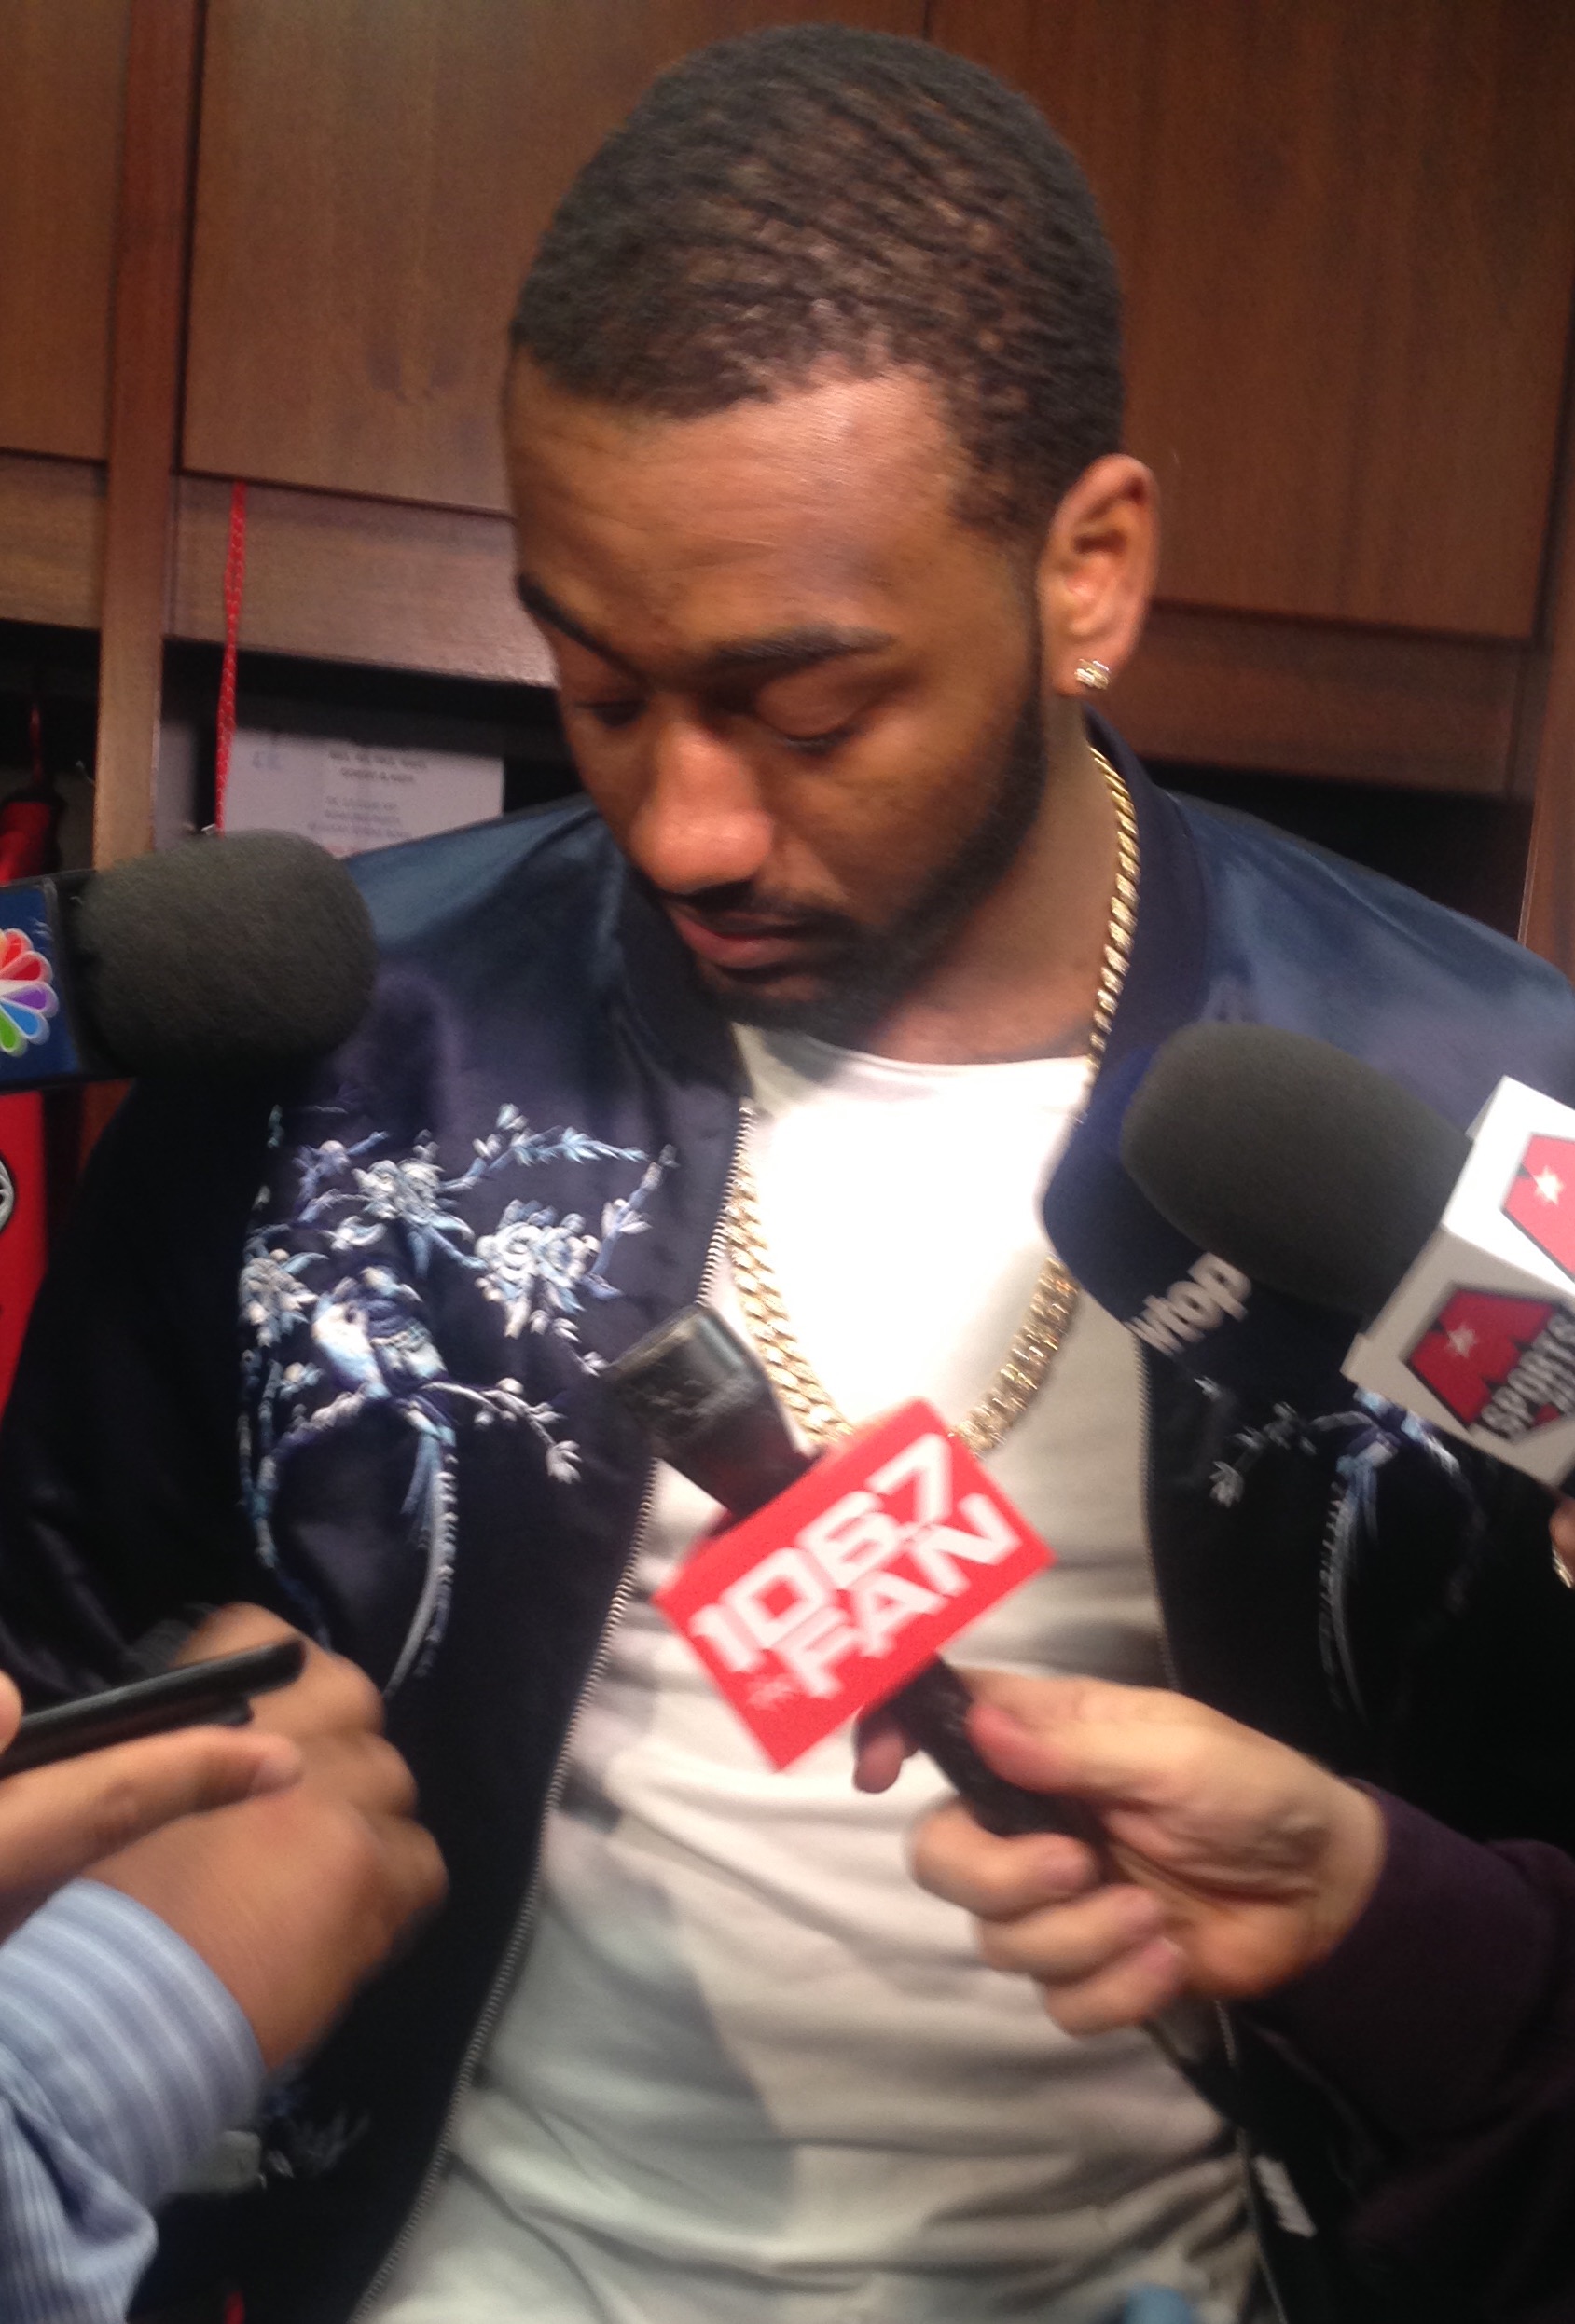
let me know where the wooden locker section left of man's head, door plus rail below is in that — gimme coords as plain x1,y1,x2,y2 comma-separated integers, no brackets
170,0,923,683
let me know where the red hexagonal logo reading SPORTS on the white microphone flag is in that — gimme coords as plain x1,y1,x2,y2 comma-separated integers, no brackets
1405,1283,1575,1443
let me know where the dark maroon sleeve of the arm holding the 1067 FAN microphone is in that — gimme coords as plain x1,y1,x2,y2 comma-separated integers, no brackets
1251,1795,1575,2324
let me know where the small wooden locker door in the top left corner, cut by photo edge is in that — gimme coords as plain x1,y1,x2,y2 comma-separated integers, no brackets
0,0,131,461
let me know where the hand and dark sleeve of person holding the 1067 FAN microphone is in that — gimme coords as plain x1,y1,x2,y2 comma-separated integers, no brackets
914,1672,1575,2324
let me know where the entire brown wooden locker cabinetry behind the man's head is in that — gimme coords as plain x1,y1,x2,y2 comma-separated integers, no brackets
0,0,1575,948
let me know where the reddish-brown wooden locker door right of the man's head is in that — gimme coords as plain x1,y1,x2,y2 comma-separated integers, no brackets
931,0,1575,637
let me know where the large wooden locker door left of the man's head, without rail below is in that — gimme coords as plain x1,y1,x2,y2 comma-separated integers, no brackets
184,0,923,509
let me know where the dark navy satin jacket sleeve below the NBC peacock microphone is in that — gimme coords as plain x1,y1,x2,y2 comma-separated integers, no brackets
0,1083,281,1701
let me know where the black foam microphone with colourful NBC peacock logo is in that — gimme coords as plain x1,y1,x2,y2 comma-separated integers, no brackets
0,832,377,1094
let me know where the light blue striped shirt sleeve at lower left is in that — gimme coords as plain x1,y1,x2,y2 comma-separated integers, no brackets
0,1880,263,2324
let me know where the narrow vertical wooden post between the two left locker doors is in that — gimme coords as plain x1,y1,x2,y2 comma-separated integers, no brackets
93,0,202,864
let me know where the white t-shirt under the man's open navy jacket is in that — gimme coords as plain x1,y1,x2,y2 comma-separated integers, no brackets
372,1034,1250,2324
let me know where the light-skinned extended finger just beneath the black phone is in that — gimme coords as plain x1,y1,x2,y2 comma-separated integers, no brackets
0,1726,300,1933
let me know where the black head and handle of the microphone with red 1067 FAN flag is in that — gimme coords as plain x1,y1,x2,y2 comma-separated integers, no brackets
602,1306,1108,1862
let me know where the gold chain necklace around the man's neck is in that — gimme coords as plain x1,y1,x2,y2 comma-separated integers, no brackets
724,750,1138,1455
